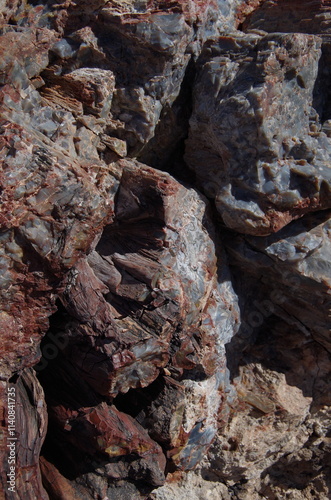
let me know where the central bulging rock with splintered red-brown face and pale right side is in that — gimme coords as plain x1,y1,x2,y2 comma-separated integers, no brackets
50,162,237,397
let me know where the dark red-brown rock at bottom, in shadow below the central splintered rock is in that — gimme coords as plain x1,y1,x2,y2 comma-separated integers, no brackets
41,368,166,496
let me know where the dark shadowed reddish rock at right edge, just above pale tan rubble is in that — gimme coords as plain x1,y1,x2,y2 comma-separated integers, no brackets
226,315,331,408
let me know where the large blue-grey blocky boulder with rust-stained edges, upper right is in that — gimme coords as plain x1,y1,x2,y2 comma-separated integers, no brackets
185,34,331,235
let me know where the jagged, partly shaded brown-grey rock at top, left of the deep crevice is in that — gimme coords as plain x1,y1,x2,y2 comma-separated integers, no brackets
33,0,227,155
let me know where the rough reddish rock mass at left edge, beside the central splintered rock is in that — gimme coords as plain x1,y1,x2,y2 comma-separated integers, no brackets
1,120,117,376
